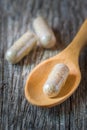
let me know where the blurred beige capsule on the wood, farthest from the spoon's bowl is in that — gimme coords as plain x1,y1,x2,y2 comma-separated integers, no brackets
33,16,56,48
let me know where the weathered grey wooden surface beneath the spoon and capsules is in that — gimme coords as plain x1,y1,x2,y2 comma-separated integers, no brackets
0,0,87,130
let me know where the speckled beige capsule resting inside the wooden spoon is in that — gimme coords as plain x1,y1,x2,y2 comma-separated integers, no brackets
43,63,69,97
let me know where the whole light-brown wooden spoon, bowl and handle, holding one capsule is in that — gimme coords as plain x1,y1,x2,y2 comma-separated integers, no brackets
25,20,87,107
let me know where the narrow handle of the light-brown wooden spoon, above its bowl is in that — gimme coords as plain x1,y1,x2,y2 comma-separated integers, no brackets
65,20,87,58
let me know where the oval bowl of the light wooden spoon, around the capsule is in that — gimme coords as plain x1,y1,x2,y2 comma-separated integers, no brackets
25,58,81,107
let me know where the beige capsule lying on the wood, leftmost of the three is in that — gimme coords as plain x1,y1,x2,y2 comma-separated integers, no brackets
5,31,37,64
